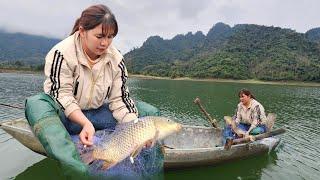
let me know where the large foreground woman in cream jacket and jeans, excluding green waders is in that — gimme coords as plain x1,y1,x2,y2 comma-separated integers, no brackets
44,5,138,145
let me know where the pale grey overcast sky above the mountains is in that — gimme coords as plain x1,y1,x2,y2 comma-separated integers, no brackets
0,0,320,52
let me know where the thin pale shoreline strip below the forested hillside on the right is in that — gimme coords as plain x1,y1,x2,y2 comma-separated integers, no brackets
129,74,320,87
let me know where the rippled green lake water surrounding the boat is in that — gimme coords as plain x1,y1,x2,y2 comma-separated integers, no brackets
0,73,320,180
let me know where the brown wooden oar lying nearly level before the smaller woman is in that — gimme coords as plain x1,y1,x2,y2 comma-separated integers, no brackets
224,128,286,150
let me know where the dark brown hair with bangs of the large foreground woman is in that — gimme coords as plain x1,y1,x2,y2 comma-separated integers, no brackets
70,4,118,36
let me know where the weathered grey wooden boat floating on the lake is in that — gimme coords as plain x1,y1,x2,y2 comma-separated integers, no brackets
1,119,284,169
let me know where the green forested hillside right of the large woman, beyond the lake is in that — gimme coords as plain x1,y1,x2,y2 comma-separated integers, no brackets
125,23,320,82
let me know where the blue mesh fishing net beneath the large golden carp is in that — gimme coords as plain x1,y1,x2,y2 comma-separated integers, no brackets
71,129,164,179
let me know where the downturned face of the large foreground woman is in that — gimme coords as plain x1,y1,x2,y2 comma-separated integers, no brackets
79,24,114,60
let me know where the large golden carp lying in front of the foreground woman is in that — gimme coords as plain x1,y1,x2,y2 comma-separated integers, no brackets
81,116,182,169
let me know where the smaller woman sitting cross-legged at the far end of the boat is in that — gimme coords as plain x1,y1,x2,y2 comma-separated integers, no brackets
224,89,267,142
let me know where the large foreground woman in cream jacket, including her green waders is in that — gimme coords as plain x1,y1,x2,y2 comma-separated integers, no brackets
26,4,162,177
